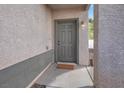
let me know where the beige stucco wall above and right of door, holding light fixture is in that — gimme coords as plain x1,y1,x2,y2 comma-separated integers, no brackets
53,8,89,65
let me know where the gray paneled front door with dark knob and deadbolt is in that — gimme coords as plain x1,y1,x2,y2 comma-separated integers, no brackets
56,20,77,62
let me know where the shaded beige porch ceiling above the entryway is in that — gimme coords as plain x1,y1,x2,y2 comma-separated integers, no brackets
48,4,89,10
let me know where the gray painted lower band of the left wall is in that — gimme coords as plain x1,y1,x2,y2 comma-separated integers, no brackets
0,49,54,88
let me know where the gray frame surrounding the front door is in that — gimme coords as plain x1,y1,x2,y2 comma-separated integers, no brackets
54,18,79,64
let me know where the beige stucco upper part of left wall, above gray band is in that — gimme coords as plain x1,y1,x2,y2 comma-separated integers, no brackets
0,5,53,69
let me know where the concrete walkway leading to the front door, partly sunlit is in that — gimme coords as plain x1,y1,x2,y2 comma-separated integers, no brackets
36,64,93,88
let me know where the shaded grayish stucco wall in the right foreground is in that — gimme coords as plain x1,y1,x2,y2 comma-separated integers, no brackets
95,5,124,87
